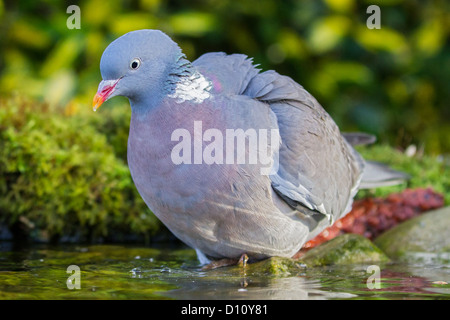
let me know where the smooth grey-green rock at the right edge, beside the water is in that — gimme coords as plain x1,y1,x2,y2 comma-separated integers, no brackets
375,207,450,263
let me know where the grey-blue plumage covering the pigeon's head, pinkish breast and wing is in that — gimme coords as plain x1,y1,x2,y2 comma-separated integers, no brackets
94,30,408,259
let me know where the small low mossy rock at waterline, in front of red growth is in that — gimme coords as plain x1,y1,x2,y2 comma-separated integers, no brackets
300,233,389,267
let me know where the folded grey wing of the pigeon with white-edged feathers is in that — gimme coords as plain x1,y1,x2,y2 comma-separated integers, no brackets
244,71,364,221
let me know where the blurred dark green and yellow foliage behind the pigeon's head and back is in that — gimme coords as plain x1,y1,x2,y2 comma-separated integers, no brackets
0,0,450,153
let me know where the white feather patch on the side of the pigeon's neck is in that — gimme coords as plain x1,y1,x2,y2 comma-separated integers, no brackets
169,71,212,103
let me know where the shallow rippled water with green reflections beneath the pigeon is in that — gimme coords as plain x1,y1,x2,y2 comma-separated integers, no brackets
0,243,450,300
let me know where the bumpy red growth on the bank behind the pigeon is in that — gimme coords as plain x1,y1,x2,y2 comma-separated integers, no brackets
302,188,444,251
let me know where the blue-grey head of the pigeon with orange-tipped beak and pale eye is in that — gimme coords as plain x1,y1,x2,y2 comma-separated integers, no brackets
92,30,183,111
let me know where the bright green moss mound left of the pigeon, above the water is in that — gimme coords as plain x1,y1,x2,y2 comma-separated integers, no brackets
0,98,159,241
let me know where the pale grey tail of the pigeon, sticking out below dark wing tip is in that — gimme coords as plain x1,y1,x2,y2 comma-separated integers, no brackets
359,161,410,189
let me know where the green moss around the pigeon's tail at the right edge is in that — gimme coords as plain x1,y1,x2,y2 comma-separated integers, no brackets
357,144,450,204
